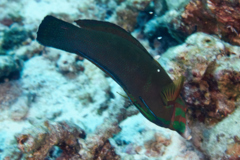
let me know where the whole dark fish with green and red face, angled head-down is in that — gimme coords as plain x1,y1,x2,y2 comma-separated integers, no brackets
37,15,190,139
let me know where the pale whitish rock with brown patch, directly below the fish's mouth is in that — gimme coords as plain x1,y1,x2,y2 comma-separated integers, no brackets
110,114,204,160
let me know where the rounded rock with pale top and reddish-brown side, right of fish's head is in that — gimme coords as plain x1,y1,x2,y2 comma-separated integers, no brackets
159,33,240,158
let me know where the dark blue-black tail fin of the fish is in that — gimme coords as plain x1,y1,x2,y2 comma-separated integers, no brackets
37,16,79,52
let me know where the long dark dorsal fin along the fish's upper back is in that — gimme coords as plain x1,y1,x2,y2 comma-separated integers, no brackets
74,19,148,54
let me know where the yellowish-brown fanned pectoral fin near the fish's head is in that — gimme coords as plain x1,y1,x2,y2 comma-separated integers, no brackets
161,76,184,105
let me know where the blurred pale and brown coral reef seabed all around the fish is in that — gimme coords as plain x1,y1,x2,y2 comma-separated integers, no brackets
0,0,240,160
